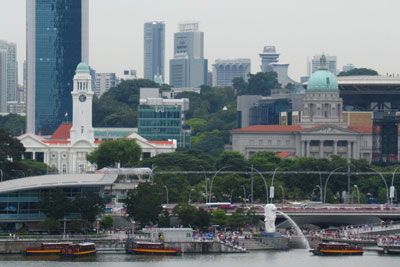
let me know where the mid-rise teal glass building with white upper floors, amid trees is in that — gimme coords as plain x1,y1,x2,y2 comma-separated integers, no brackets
138,88,190,147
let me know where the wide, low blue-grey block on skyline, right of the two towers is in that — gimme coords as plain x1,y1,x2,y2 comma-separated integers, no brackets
212,58,251,86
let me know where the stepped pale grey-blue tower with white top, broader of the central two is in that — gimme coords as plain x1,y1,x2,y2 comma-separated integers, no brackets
169,23,208,88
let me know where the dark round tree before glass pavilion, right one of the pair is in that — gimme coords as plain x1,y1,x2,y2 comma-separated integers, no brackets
72,191,105,223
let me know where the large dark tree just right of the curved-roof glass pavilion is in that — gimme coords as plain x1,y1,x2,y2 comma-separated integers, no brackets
125,182,162,227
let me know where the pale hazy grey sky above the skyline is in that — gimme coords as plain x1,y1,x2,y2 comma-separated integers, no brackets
0,0,400,83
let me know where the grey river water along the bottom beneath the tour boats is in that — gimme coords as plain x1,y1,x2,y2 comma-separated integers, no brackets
0,250,400,267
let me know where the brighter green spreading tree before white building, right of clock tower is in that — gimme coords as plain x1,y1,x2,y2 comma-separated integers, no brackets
87,138,142,169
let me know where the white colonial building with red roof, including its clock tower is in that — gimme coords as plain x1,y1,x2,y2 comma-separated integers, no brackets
18,63,177,173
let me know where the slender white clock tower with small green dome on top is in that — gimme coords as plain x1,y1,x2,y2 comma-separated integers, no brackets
70,62,94,145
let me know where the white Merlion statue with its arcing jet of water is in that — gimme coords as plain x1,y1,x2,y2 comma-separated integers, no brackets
264,204,310,249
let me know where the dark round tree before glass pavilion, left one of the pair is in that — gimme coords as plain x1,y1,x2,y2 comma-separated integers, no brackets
38,188,73,220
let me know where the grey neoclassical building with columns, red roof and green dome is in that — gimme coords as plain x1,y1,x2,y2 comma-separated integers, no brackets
231,56,378,161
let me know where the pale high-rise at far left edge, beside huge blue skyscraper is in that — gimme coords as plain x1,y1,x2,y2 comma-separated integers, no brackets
0,40,18,106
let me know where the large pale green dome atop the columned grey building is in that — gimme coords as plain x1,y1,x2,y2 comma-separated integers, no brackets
307,69,339,91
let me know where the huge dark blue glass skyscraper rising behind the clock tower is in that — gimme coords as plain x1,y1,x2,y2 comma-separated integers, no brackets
26,0,89,135
